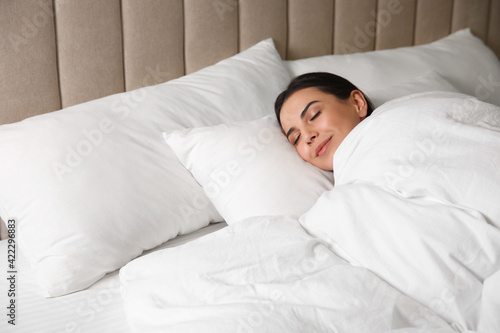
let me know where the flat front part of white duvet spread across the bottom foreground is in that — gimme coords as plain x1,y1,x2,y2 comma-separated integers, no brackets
120,217,454,333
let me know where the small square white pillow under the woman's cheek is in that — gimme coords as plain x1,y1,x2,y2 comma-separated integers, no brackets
164,115,333,224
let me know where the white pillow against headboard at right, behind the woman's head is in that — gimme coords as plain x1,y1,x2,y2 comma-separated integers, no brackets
285,29,500,106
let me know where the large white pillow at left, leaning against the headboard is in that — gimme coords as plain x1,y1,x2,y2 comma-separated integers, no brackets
0,39,290,296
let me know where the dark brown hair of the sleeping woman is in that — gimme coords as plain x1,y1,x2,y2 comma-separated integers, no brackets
274,72,374,126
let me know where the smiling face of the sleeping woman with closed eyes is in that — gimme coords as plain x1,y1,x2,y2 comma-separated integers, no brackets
280,88,368,171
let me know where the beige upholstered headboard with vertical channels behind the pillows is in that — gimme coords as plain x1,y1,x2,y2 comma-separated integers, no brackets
0,0,500,239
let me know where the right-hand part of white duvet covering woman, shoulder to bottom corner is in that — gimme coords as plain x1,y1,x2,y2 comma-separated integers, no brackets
301,93,500,332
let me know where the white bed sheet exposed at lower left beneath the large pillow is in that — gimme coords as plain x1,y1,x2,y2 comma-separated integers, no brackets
0,223,226,333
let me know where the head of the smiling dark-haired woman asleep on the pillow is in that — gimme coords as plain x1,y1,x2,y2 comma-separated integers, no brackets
274,72,373,171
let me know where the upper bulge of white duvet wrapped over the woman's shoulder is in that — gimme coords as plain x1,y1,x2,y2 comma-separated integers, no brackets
334,92,500,227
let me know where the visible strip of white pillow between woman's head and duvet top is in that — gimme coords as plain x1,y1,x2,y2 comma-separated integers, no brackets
366,71,460,108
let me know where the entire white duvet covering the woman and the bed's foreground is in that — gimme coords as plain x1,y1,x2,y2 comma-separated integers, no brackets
120,93,500,333
